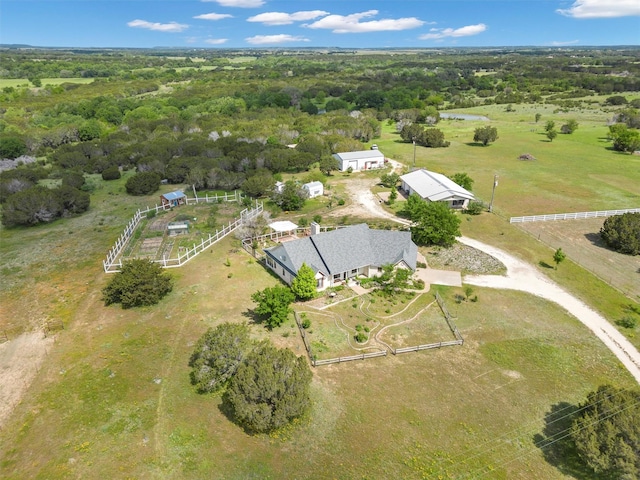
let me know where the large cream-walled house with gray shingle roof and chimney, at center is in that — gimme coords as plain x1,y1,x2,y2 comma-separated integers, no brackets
265,223,418,290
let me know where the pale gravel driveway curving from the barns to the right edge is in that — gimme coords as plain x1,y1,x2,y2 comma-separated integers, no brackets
336,160,640,384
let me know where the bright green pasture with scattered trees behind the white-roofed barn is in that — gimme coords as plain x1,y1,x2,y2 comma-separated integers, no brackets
376,105,640,217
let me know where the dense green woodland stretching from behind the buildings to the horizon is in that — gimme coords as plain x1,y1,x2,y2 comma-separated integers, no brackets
0,48,640,225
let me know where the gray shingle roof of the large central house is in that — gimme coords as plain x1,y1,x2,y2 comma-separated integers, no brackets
265,223,418,275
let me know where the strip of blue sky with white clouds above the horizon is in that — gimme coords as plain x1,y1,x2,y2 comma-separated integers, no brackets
0,0,640,48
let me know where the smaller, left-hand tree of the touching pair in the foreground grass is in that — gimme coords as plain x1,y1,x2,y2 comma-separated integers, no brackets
189,323,252,393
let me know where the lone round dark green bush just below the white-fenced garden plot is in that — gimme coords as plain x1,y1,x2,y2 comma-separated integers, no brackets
102,259,173,308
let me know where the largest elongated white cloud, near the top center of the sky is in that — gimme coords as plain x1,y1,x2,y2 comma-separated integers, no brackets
305,10,424,33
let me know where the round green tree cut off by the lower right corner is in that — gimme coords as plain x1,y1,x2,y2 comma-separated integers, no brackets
571,385,640,479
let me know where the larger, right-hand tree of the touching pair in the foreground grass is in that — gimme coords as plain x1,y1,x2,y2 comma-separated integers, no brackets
223,342,312,433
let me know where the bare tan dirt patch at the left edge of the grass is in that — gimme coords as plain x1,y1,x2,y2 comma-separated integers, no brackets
0,332,53,427
